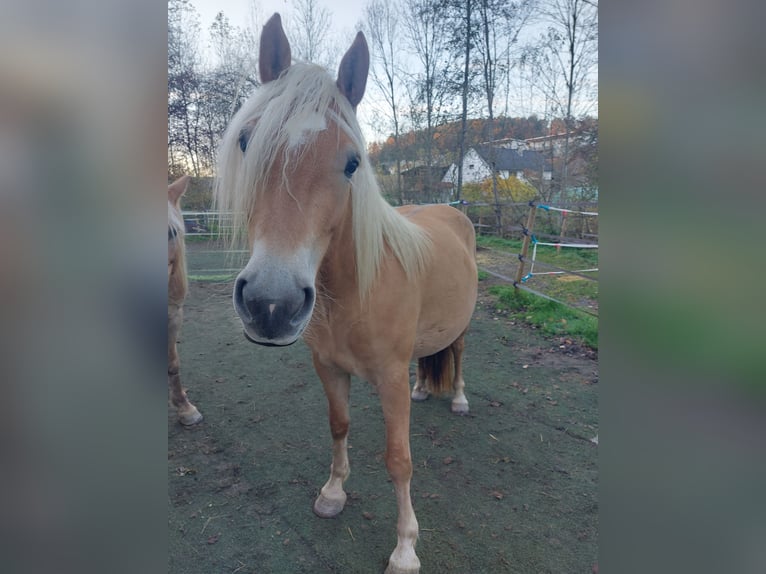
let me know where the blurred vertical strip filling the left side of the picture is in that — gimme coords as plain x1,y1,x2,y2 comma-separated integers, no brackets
0,0,167,572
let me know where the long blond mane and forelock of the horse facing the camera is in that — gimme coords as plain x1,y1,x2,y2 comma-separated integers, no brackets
214,63,430,297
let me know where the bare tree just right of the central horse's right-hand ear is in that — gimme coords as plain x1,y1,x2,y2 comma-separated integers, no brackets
365,0,404,203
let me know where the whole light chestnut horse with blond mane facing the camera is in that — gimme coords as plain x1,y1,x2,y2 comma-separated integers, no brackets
215,13,477,574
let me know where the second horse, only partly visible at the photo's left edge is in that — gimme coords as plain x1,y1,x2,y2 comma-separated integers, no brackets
168,175,202,426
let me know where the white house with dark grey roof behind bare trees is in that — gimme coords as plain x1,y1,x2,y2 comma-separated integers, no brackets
442,145,551,191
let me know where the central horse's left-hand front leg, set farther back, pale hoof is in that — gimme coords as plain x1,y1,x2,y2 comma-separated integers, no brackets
314,355,351,518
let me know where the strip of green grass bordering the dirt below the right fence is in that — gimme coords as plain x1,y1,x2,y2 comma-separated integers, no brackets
489,285,598,349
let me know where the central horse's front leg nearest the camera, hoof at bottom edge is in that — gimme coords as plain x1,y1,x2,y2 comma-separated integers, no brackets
376,364,420,574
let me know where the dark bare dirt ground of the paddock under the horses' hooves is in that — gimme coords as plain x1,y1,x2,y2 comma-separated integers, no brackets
168,281,598,574
